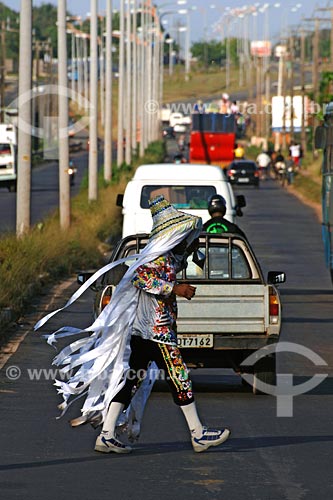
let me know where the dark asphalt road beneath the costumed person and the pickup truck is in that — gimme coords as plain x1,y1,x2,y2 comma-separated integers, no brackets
0,170,333,500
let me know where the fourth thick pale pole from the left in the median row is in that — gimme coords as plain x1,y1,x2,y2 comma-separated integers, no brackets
104,0,112,181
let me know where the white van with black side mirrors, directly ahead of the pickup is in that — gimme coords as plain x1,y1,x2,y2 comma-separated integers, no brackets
117,163,245,238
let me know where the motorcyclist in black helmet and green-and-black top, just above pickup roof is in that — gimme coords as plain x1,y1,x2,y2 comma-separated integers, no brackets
202,194,246,238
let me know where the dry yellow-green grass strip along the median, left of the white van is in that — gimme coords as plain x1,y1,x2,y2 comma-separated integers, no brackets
0,142,165,314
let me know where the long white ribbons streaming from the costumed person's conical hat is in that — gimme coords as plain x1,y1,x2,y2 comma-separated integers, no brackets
34,224,200,421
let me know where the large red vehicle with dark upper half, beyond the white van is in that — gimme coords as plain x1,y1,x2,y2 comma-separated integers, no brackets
190,113,237,168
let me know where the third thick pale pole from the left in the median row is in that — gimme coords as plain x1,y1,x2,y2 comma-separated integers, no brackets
88,0,98,202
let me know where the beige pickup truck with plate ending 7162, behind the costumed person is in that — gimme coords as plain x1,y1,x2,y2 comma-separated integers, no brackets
78,233,285,394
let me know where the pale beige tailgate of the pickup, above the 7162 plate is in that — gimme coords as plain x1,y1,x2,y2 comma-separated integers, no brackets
177,284,268,335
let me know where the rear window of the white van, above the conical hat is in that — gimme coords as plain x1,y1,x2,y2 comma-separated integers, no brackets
140,185,216,210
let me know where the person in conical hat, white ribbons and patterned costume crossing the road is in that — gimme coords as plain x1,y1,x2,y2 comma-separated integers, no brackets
35,196,230,453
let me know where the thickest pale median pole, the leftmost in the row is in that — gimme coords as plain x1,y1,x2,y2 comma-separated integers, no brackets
16,0,32,236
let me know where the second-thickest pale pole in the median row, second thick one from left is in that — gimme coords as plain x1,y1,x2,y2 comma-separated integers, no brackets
58,0,71,229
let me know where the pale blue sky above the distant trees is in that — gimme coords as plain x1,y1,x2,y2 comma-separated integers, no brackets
2,0,332,42
